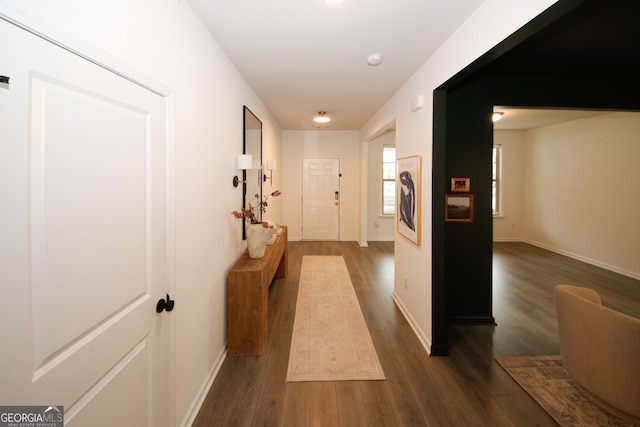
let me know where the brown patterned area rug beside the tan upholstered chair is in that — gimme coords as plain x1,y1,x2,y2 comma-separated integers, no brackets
496,356,631,427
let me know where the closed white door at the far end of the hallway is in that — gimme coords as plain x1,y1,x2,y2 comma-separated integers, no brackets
302,158,340,240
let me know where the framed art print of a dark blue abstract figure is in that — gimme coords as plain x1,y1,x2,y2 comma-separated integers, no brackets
396,155,422,246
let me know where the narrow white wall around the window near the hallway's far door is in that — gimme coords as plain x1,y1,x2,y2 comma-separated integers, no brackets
367,131,396,242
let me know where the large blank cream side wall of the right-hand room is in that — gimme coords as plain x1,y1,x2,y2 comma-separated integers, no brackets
523,113,640,278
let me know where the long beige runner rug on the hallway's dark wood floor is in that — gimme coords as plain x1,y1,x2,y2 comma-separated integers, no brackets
287,255,385,382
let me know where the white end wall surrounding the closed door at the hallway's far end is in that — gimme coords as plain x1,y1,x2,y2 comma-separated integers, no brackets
282,130,360,241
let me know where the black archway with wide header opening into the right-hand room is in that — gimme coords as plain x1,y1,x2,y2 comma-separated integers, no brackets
432,0,640,355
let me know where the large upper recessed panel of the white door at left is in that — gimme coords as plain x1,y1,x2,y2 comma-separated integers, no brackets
30,77,150,368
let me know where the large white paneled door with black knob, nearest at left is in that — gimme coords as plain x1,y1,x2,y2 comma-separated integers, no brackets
0,19,171,426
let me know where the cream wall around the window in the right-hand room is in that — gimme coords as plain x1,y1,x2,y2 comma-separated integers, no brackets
493,130,526,242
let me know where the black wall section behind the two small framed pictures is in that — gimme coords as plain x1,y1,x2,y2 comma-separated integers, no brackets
443,83,493,323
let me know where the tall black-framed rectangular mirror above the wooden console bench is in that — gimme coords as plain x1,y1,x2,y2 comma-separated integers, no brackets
242,105,263,239
